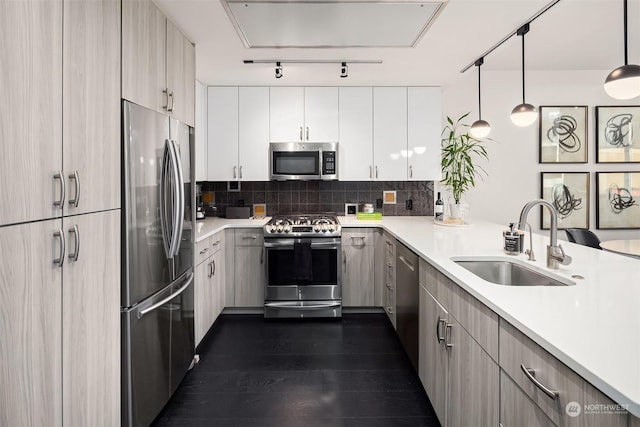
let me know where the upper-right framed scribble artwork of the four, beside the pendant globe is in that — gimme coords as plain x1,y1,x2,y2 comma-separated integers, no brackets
596,106,640,163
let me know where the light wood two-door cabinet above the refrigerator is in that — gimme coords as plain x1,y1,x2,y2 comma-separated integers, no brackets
122,0,195,126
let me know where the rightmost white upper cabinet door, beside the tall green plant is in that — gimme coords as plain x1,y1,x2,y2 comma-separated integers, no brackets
407,87,442,181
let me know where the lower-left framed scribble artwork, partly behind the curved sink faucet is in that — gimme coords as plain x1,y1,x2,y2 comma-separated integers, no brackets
540,172,589,230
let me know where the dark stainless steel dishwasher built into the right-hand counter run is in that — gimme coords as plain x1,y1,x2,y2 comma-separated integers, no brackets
396,242,420,372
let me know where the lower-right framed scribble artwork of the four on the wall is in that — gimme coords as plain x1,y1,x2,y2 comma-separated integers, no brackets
596,172,640,229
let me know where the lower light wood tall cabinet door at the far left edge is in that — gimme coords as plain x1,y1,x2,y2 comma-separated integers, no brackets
0,219,62,426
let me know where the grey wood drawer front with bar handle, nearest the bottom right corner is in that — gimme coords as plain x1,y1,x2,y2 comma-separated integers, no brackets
500,319,627,427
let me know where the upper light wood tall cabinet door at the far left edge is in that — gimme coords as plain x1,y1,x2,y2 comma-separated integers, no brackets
0,0,64,226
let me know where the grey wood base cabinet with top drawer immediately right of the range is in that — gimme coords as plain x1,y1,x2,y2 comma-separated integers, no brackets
342,228,376,307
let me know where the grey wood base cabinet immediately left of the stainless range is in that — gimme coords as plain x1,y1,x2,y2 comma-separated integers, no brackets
232,228,265,307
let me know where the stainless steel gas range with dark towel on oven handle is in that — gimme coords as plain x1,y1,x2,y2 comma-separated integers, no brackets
264,214,342,317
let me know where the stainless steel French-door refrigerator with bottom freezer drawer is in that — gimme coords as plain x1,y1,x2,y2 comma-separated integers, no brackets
121,101,195,426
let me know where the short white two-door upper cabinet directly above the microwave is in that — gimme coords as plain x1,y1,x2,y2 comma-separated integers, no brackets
269,87,338,142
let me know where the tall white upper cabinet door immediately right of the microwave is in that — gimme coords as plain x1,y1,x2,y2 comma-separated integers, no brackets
338,87,373,181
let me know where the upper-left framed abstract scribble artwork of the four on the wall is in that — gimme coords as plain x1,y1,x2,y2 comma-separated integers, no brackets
539,105,588,163
